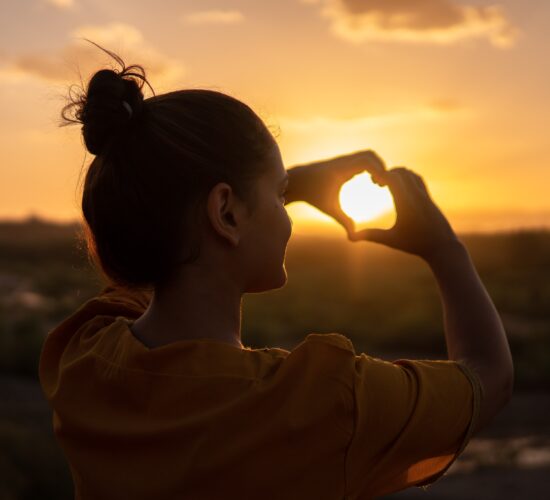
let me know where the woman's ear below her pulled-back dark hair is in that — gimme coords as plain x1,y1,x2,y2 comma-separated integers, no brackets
206,182,244,247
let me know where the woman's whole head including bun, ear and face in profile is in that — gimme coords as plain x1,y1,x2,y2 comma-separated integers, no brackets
62,42,290,291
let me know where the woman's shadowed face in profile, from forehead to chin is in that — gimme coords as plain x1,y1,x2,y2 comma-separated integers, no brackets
243,143,292,292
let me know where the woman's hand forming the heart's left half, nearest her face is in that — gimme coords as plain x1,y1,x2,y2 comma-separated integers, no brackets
286,150,386,237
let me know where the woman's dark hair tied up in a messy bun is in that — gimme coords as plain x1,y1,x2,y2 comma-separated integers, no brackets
61,40,275,288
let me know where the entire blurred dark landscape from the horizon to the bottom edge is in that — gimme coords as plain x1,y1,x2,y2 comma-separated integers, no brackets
0,218,550,500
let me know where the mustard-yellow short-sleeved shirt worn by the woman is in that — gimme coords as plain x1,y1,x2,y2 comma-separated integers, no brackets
39,286,482,500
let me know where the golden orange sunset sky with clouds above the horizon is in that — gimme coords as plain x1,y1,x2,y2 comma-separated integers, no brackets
0,0,550,232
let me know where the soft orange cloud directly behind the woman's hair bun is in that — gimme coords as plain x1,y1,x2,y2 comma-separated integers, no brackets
0,23,184,88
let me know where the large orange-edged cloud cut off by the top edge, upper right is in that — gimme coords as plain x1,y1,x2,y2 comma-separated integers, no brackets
301,0,519,48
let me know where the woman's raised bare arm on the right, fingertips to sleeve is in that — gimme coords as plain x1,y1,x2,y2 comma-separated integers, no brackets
352,168,514,432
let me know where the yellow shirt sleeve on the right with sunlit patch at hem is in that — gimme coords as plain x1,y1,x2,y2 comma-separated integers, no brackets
346,353,482,498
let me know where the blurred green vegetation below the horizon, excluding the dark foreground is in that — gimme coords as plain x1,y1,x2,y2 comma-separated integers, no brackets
0,218,550,388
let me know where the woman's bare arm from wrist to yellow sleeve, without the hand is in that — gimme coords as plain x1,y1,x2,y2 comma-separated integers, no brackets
428,242,513,425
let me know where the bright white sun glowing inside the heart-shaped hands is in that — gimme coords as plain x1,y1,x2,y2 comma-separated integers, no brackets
340,173,393,222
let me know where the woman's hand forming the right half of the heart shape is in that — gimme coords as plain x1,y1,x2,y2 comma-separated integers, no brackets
350,167,460,262
